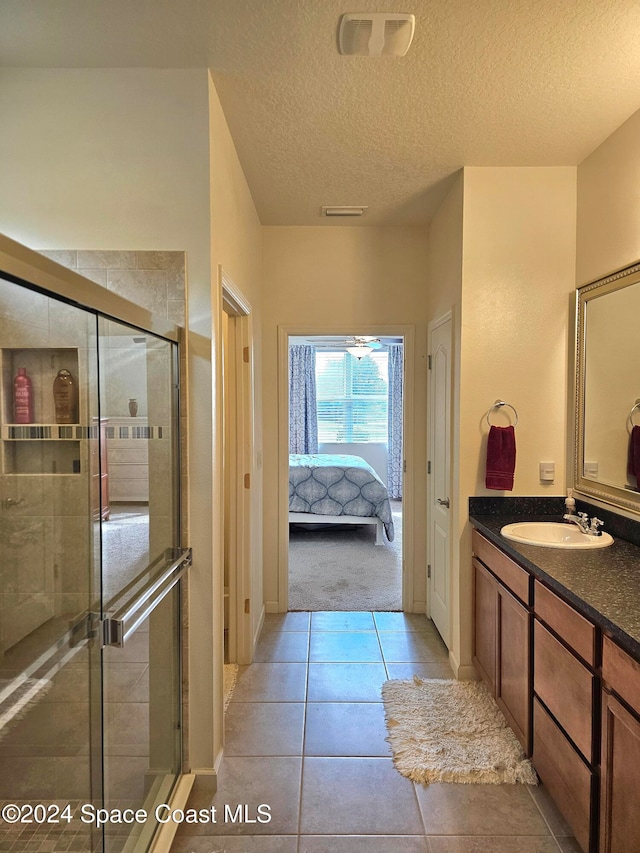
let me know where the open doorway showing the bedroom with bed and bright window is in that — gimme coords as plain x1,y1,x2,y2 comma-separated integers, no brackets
279,327,413,612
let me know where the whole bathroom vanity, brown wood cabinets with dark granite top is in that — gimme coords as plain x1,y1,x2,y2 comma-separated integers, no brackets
471,499,640,853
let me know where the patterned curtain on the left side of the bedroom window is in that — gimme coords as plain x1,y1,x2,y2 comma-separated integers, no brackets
289,344,318,453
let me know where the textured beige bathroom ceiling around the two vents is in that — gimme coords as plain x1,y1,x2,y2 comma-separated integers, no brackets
0,0,640,225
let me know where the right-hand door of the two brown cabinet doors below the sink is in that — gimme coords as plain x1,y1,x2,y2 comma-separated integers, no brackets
496,585,531,755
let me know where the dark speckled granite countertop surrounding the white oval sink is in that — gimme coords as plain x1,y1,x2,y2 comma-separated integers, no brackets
469,510,640,660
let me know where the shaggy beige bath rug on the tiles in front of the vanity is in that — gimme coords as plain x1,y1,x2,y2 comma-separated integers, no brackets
382,676,538,785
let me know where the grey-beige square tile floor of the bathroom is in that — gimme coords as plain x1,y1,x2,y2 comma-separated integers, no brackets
172,612,579,853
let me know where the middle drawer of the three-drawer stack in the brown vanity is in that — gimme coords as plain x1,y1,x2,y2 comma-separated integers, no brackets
533,619,593,761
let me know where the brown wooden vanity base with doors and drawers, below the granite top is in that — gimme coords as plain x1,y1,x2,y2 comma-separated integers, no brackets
473,530,640,853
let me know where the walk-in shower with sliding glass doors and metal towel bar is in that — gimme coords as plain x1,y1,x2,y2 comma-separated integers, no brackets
0,241,191,853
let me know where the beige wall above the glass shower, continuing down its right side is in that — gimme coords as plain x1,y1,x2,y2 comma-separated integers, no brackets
0,69,221,769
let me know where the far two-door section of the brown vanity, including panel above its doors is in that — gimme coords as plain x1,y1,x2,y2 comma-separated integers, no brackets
473,532,531,755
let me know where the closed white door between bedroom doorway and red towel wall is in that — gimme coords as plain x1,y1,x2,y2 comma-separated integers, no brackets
427,313,452,648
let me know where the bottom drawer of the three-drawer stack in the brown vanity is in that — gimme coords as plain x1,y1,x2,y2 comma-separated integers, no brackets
533,698,593,853
